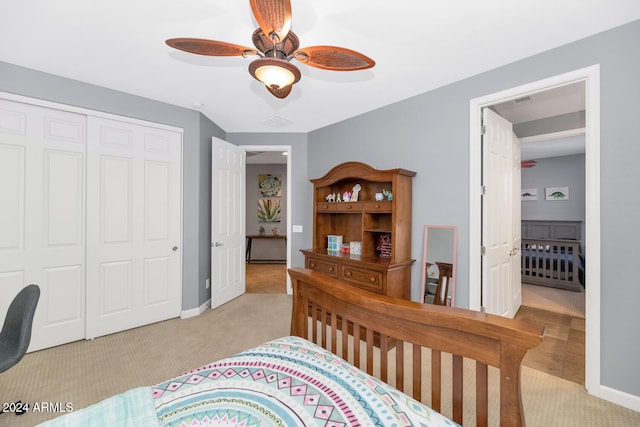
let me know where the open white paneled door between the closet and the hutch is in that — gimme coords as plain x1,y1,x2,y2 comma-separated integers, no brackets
211,138,246,308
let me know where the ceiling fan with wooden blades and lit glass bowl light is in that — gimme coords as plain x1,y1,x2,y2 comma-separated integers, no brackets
166,0,375,98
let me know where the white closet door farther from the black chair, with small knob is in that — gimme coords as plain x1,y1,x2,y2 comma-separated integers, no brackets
86,117,182,338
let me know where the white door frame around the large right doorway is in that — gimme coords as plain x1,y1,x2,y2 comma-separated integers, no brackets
469,65,600,396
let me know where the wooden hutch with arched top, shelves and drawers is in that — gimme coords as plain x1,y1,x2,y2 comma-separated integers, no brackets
302,162,416,300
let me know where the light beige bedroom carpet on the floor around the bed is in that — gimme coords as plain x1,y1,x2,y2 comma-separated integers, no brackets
0,294,640,427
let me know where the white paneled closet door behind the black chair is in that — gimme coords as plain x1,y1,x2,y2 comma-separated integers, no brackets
0,100,86,351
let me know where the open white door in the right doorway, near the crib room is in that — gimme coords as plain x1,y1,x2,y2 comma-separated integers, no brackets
482,108,521,317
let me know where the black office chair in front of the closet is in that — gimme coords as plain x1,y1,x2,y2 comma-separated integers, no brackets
0,285,40,414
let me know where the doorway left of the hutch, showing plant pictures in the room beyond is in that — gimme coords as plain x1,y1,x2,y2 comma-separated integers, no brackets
241,145,292,294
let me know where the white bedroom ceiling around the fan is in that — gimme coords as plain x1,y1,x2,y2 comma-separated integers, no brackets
0,0,640,133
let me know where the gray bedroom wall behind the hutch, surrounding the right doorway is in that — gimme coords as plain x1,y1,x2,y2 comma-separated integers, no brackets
309,21,640,396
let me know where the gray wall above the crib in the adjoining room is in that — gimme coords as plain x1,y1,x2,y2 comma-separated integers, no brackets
521,154,585,221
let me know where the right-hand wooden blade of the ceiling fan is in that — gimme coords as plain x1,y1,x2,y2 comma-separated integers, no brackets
293,46,376,71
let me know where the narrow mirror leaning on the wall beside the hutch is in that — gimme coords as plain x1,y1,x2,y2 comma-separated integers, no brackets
421,225,458,306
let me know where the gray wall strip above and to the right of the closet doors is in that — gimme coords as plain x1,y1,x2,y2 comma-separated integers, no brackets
0,62,225,310
